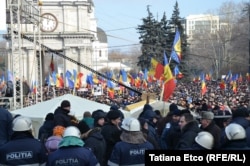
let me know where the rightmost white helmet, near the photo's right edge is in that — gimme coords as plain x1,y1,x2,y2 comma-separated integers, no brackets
225,123,246,140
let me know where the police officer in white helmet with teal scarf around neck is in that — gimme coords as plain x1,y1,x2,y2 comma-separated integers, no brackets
47,126,99,166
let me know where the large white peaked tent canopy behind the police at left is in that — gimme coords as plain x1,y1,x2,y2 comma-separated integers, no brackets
11,94,130,136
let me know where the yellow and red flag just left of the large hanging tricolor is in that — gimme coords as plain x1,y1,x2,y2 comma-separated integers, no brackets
148,58,164,80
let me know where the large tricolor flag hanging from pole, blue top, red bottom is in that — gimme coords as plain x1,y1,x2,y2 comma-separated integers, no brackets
162,51,176,101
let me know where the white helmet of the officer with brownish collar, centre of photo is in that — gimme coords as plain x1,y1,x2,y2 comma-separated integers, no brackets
121,117,141,131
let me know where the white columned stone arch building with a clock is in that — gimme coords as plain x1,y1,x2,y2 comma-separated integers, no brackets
10,0,108,82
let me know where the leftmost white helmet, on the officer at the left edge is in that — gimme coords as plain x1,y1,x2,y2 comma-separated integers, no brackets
12,116,32,131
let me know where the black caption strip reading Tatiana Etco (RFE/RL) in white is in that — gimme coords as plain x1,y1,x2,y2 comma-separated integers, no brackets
145,150,250,166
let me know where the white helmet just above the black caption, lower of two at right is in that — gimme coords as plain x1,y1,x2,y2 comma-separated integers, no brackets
195,131,214,149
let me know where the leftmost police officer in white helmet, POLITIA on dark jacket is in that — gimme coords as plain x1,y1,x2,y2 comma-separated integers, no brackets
0,116,47,165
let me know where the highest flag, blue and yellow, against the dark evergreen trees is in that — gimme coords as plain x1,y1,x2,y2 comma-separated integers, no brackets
170,29,181,63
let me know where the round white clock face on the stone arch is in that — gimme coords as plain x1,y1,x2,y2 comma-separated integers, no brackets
41,13,58,32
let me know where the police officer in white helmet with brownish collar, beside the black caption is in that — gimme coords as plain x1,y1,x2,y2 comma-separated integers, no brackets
108,118,154,166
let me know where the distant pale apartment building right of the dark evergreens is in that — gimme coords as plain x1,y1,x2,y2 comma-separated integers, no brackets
186,14,220,40
